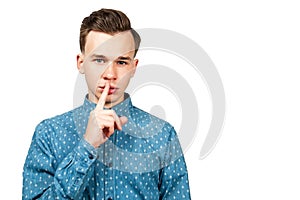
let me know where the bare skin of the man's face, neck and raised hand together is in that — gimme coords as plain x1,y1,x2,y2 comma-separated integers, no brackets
77,31,138,148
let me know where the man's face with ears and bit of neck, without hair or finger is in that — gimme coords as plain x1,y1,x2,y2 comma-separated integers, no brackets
77,31,138,108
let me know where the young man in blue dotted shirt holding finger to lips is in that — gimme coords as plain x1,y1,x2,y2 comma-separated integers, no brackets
22,9,190,200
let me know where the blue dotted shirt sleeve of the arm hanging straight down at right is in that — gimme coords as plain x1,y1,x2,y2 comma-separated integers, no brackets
159,128,191,200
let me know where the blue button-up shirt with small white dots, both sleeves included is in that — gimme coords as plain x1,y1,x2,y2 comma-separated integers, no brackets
22,94,190,200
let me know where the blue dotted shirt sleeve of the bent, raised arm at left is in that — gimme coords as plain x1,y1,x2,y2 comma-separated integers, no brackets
22,123,97,200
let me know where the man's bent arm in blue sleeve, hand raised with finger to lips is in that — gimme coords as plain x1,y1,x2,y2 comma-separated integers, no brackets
23,84,127,200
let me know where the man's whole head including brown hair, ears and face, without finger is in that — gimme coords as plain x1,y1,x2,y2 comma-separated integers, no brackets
77,9,140,107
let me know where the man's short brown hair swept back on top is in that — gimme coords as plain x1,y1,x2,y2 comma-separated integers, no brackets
79,8,141,56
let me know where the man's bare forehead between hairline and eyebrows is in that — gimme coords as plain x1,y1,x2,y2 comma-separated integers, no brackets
85,31,135,58
